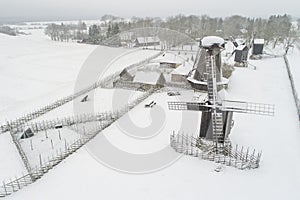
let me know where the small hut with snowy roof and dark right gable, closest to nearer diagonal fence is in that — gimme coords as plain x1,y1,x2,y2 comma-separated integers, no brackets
133,71,166,90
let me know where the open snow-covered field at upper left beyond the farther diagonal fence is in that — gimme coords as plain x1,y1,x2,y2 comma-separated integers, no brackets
0,30,158,124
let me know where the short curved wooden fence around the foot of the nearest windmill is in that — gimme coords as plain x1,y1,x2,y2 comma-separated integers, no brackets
170,133,261,170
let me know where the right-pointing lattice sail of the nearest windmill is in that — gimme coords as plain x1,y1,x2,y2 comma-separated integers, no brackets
218,100,275,116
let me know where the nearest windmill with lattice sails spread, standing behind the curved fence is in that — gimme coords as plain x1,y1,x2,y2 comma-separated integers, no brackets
168,36,274,153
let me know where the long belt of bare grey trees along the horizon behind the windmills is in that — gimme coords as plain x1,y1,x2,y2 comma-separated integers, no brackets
46,14,300,44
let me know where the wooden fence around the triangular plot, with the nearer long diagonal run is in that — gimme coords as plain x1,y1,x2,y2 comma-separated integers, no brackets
0,90,155,197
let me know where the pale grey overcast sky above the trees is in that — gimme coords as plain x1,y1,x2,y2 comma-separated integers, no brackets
0,0,300,20
